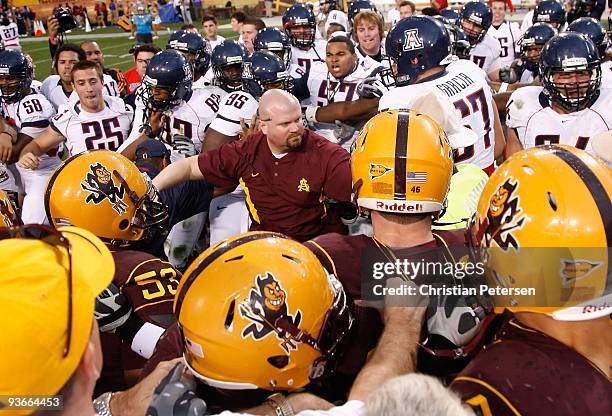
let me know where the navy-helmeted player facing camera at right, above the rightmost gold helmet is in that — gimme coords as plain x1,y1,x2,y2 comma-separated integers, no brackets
506,32,612,154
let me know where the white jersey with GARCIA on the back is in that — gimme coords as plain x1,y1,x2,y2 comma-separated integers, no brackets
378,60,495,169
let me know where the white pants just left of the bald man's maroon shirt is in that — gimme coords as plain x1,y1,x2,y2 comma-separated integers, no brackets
208,186,251,247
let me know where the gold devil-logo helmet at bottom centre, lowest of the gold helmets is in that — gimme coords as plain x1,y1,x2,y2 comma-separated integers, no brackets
174,232,353,390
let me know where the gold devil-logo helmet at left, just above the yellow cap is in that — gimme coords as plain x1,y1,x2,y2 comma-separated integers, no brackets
45,150,168,245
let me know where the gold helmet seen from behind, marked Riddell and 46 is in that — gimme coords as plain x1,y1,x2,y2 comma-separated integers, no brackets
351,110,453,214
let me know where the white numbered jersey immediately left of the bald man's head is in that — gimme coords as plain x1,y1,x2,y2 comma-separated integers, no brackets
209,91,259,137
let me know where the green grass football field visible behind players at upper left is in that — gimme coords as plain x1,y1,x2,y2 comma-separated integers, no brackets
21,23,238,81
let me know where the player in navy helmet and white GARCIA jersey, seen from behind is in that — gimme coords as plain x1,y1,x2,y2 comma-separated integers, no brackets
378,16,505,175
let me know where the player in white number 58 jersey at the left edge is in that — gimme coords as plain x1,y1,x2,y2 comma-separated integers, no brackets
0,49,60,224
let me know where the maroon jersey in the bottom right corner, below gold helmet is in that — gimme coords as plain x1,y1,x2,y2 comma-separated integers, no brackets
451,319,612,416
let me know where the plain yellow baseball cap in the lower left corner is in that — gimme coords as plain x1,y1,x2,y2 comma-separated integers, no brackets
0,226,115,414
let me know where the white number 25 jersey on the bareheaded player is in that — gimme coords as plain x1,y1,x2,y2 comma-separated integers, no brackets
51,97,134,155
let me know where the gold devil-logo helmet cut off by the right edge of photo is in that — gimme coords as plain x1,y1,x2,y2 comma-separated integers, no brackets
469,145,612,321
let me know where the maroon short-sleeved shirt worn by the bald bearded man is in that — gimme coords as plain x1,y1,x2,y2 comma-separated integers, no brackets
198,129,351,241
